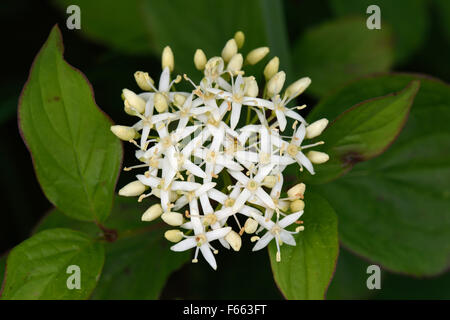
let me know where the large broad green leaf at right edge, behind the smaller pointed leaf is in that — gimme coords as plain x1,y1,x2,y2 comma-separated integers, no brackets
312,74,450,275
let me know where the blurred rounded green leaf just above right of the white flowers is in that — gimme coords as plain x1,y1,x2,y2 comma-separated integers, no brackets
293,18,393,96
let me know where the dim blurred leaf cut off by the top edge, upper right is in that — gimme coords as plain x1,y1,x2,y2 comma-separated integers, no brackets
330,0,429,63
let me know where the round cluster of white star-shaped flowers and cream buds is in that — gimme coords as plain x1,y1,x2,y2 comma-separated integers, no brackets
111,31,328,269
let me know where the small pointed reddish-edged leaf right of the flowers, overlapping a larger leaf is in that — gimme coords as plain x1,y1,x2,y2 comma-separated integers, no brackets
303,81,420,183
